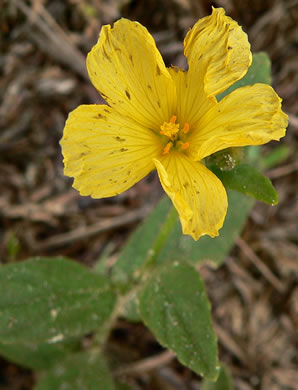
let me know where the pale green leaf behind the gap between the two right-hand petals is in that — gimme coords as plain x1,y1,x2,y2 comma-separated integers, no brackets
217,52,271,101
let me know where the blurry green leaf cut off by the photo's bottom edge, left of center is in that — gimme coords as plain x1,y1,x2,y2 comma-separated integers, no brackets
34,352,115,390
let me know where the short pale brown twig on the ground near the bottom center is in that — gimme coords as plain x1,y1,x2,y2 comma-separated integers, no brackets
115,350,176,375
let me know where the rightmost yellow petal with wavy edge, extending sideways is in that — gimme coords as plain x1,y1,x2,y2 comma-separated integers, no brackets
188,84,288,161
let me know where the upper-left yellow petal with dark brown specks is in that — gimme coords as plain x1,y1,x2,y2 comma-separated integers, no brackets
87,19,176,130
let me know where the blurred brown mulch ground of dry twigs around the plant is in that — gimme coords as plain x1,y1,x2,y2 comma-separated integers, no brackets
0,0,298,390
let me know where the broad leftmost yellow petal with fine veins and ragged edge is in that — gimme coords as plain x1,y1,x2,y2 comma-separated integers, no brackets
61,105,163,198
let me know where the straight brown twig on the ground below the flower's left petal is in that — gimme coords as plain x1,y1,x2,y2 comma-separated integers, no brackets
34,206,151,251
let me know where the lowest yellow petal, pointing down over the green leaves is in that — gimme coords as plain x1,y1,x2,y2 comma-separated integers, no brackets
154,152,228,240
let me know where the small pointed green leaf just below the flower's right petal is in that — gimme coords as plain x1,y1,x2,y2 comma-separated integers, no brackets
209,164,278,205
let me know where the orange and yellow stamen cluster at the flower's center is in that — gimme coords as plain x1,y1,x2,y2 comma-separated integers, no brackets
160,115,189,154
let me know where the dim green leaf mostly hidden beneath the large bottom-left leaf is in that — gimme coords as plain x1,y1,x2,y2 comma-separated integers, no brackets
0,340,79,370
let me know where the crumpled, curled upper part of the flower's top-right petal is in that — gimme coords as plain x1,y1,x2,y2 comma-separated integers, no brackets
184,8,252,101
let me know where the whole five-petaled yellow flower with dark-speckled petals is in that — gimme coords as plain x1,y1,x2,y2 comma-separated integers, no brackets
61,8,287,240
